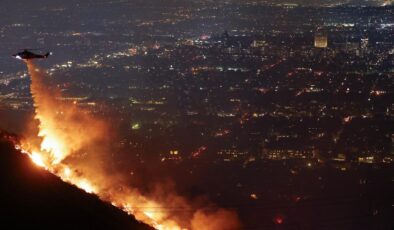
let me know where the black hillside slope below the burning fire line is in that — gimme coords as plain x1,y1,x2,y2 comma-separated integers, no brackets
0,132,151,230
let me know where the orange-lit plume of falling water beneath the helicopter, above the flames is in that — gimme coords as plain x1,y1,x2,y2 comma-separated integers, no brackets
27,61,108,164
